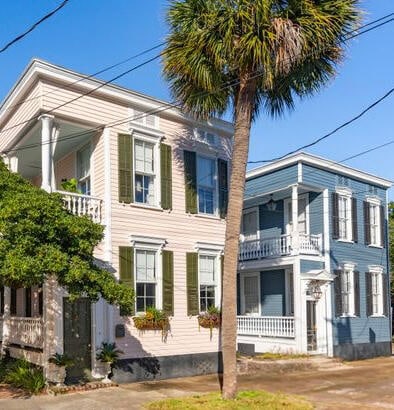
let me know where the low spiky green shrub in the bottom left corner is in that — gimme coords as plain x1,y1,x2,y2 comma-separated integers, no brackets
4,359,45,394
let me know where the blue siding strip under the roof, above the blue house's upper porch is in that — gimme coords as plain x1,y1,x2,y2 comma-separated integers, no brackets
245,165,298,198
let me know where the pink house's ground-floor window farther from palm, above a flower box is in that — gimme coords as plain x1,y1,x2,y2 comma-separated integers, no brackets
135,249,157,312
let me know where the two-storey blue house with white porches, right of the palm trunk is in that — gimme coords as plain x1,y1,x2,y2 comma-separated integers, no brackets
237,153,391,360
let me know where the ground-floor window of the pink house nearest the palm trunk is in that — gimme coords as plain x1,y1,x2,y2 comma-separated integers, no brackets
198,255,217,312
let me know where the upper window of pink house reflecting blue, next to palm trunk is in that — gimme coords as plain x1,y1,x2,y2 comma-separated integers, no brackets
197,156,216,215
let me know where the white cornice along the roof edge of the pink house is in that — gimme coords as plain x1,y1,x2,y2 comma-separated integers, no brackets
0,59,234,136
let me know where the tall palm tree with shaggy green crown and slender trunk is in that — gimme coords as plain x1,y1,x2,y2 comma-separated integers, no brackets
163,0,360,398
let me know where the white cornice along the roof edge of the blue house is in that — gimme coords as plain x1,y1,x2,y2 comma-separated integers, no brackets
246,152,392,188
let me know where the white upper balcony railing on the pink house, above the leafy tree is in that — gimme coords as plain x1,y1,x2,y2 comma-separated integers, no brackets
57,191,102,223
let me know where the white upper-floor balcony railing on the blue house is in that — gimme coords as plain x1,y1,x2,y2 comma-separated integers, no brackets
239,234,322,262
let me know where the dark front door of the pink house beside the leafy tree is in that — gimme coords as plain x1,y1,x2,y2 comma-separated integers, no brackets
63,298,92,382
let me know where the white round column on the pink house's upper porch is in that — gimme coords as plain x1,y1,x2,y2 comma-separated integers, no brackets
39,114,54,192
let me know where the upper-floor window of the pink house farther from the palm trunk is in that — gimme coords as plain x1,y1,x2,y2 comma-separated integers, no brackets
134,139,156,205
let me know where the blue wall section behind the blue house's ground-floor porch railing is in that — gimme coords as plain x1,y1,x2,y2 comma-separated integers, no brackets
260,269,286,316
